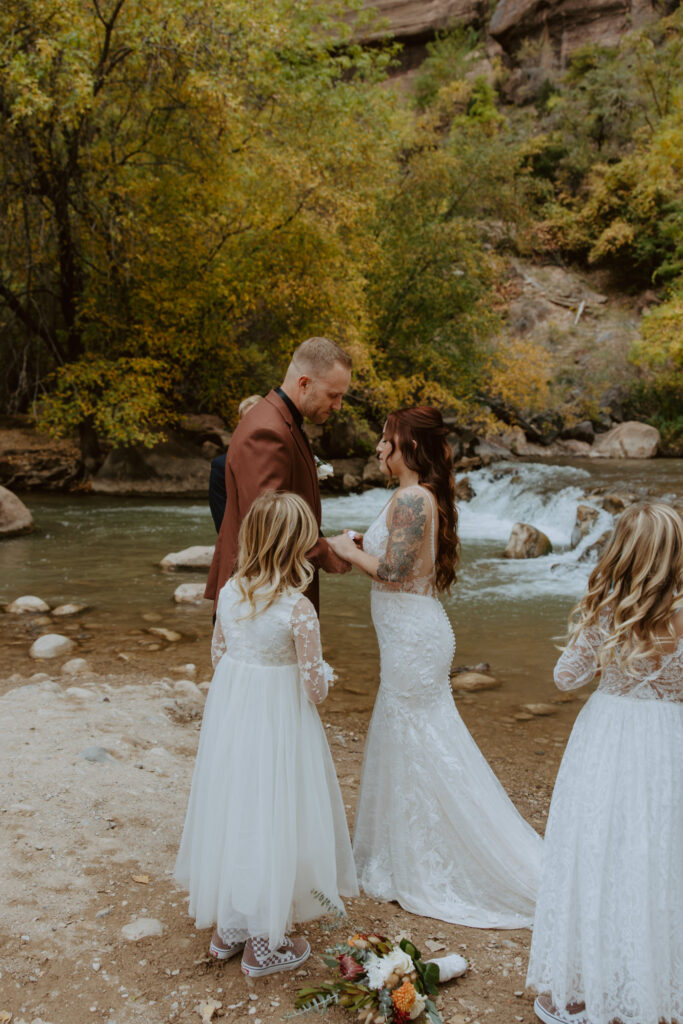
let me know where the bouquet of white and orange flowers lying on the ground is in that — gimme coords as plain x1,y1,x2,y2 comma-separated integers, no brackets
295,933,467,1024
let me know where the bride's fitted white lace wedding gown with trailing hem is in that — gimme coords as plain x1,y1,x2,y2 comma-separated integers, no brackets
353,485,543,928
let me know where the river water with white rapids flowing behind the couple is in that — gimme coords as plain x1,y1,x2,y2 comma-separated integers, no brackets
0,460,683,708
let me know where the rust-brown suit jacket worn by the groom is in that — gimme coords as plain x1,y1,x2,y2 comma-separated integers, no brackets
204,391,334,610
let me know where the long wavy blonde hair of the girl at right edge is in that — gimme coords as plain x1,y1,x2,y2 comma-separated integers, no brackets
568,503,683,673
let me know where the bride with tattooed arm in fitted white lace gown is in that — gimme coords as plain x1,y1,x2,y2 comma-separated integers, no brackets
330,407,542,928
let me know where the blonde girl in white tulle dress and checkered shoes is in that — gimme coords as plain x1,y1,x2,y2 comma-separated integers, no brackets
174,492,357,977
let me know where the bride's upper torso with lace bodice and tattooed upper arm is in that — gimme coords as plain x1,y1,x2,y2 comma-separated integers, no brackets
362,483,436,597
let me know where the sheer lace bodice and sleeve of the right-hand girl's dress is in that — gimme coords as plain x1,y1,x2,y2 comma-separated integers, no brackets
554,627,683,701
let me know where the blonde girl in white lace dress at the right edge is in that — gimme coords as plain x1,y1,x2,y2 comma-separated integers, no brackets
526,504,683,1024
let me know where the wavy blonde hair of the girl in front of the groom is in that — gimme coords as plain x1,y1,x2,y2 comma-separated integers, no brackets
232,490,317,618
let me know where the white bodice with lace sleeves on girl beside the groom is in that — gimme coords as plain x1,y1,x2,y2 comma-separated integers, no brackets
211,580,334,703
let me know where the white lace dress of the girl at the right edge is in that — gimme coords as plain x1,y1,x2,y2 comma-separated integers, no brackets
527,621,683,1024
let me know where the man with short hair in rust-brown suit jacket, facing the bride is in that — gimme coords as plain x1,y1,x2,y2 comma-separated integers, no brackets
204,338,351,610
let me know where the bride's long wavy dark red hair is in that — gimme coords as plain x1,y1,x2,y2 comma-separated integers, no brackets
384,406,460,592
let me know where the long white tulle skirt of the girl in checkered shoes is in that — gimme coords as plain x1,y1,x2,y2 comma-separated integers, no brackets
174,654,357,946
